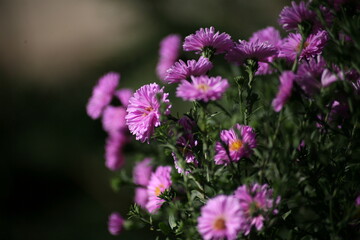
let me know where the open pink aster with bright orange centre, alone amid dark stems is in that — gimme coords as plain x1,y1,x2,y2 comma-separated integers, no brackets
214,124,256,165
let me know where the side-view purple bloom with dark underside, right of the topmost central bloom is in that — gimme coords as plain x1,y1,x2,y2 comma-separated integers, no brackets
225,40,278,65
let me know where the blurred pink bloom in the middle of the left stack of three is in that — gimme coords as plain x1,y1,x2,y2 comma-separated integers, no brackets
102,106,126,134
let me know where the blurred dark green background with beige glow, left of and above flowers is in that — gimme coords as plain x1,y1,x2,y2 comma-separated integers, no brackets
0,0,290,240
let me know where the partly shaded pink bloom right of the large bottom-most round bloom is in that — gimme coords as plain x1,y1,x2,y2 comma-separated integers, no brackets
234,183,280,236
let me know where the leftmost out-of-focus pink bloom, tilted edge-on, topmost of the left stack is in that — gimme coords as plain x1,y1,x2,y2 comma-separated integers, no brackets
86,72,120,119
